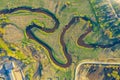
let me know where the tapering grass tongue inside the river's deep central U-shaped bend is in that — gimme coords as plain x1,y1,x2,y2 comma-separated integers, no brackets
35,31,66,63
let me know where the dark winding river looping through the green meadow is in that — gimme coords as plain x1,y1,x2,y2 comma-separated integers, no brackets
0,6,120,68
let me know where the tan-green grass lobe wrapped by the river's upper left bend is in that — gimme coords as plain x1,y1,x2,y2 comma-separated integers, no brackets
7,10,54,30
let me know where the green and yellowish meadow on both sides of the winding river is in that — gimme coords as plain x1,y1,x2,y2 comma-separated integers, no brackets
0,0,120,80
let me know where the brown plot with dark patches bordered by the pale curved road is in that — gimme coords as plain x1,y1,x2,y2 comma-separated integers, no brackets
75,62,120,80
